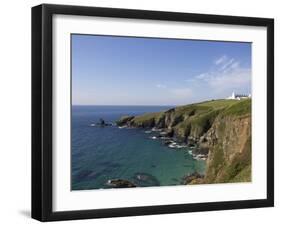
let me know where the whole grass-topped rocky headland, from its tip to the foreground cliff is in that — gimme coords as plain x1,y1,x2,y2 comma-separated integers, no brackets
116,99,251,184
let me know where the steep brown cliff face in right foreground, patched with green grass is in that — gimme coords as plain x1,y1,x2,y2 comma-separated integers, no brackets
199,115,251,183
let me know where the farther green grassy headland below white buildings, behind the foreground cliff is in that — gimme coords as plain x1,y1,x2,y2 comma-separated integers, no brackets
117,99,251,142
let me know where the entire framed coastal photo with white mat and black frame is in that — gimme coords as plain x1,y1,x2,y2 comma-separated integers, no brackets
32,4,274,221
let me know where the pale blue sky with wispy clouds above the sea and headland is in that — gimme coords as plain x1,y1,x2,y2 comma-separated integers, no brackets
72,35,251,105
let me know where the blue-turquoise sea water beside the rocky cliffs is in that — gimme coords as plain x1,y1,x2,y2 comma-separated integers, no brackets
71,106,205,190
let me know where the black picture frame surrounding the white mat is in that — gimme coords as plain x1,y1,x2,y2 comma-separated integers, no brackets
32,4,274,221
